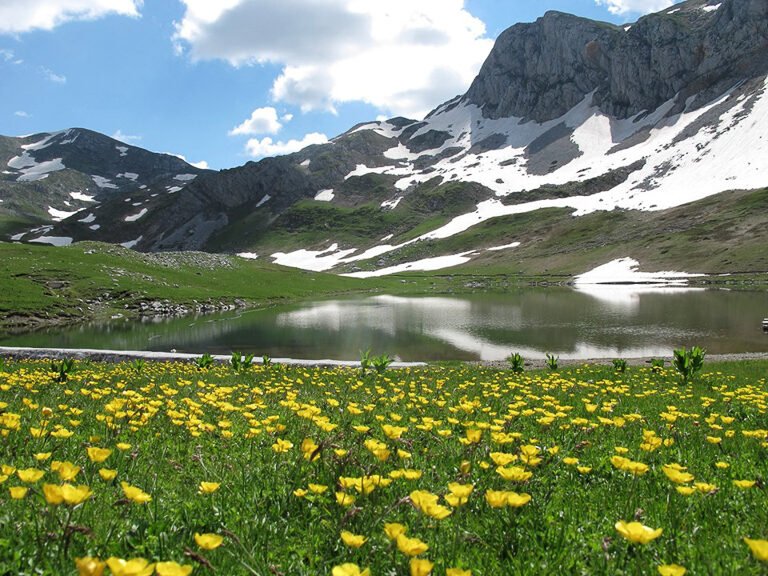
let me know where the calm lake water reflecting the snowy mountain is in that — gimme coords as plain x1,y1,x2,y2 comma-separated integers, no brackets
0,286,768,361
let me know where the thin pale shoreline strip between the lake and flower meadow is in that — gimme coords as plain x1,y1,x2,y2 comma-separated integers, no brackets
0,346,768,370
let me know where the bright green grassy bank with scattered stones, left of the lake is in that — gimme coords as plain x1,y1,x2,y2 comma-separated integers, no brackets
0,242,392,327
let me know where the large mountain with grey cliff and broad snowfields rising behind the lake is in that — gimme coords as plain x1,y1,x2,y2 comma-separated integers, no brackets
6,0,768,274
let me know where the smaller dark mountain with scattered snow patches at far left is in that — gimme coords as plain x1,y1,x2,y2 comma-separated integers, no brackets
0,128,206,244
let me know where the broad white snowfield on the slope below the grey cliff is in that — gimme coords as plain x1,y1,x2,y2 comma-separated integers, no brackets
272,80,768,270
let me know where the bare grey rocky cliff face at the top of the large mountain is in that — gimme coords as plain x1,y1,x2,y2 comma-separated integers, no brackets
464,0,768,122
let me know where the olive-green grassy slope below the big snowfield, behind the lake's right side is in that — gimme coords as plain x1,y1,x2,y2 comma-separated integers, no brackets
342,189,768,278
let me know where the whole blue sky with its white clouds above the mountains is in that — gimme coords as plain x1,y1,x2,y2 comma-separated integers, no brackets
0,0,673,169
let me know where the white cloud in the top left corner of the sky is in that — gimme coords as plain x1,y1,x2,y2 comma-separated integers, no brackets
0,0,144,34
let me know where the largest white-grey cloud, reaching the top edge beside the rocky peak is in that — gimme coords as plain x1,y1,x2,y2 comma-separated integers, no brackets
174,0,493,117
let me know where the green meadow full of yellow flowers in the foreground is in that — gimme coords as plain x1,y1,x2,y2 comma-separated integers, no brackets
0,361,768,576
